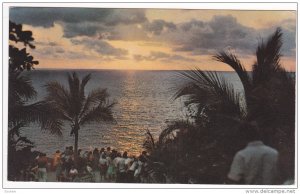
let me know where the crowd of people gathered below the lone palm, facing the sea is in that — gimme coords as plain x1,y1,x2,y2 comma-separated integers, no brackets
25,146,149,183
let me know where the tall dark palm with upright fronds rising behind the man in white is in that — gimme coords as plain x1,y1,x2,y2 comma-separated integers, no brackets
214,28,295,141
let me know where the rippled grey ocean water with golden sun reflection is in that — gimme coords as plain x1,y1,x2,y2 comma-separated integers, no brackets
22,70,242,155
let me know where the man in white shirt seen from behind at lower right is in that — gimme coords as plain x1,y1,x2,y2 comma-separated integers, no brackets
228,124,278,185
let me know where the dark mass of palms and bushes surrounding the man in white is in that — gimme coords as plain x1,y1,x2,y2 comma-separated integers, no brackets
146,29,295,184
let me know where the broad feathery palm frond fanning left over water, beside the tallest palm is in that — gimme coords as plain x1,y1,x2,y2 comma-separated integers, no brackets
174,69,242,115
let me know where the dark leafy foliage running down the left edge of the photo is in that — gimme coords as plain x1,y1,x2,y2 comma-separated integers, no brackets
8,22,38,180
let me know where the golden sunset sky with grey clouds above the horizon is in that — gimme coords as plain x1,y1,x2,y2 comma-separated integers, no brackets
9,7,296,71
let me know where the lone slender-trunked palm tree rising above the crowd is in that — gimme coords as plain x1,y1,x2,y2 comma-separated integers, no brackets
43,72,115,157
